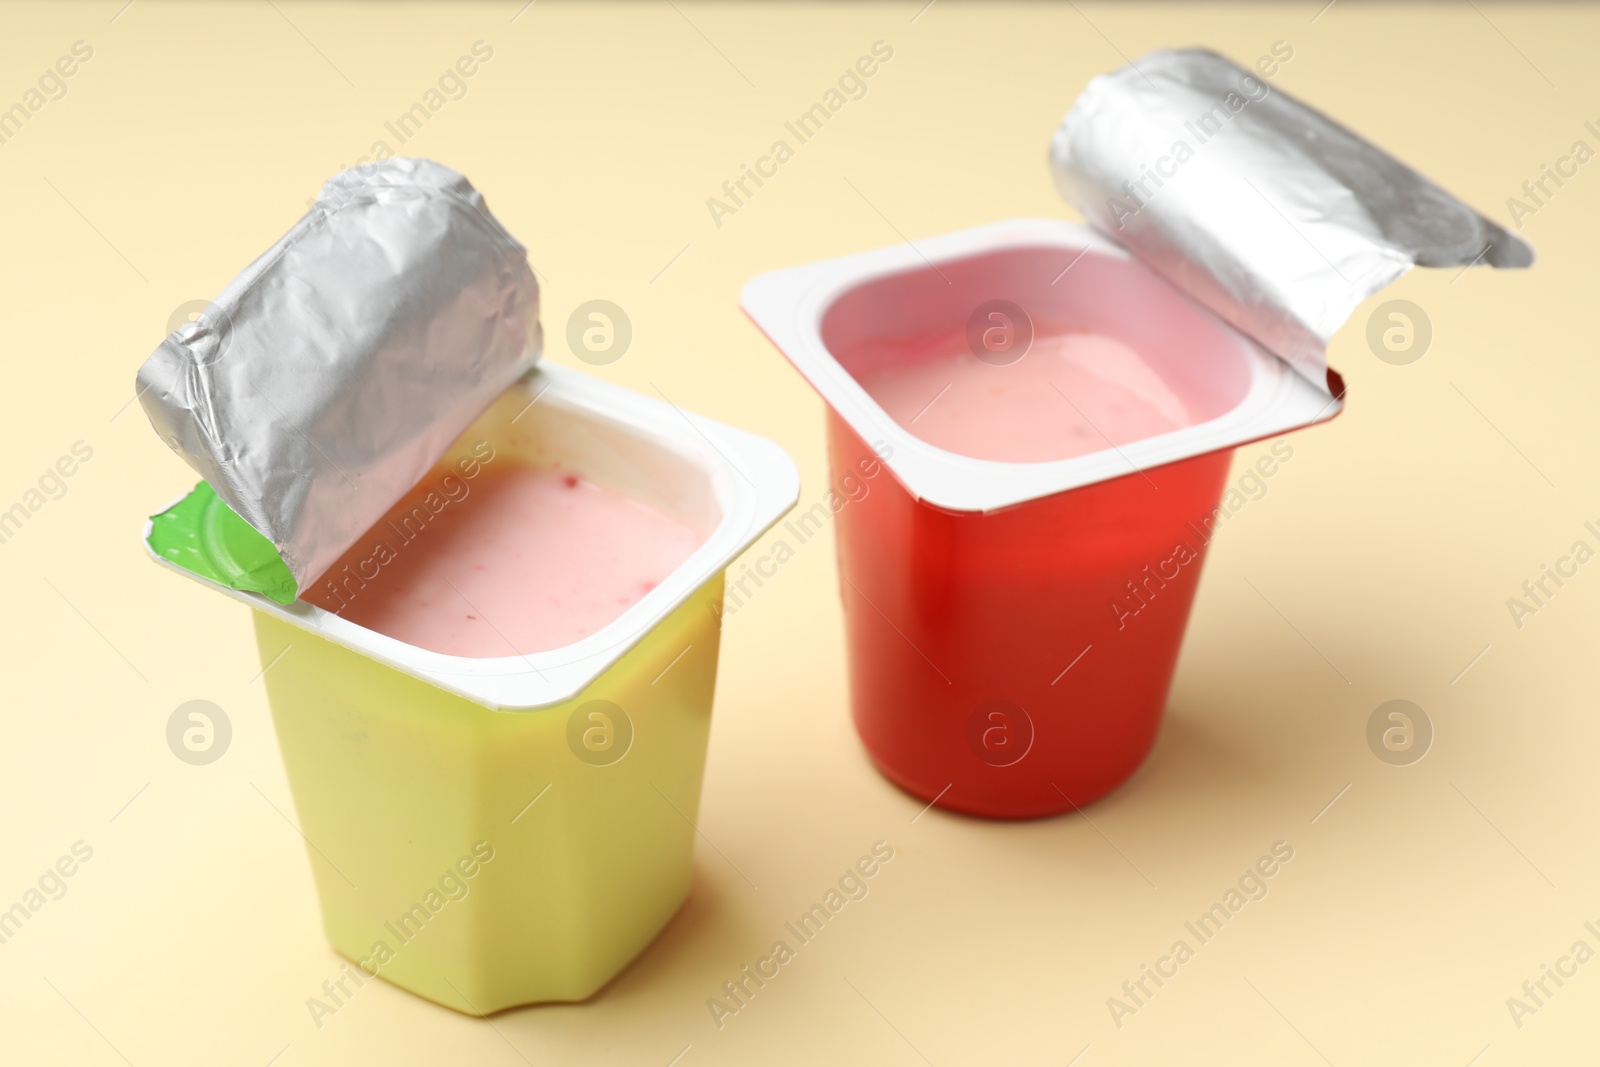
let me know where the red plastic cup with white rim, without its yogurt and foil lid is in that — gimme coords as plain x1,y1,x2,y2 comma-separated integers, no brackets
742,221,1339,819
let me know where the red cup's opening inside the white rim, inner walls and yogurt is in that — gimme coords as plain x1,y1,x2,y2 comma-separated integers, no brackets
821,245,1251,462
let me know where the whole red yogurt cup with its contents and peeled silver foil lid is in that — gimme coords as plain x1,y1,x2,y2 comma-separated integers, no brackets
741,51,1533,817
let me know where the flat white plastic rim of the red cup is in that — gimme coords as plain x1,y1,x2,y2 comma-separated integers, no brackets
739,219,1342,512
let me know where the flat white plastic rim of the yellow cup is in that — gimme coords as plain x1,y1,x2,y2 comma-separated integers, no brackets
144,363,800,710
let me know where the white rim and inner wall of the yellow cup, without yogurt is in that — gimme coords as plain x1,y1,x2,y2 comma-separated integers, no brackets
144,365,800,712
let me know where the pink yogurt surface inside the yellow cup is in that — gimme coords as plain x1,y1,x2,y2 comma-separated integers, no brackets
304,461,701,657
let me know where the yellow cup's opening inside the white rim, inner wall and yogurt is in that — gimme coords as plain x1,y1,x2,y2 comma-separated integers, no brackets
302,389,723,659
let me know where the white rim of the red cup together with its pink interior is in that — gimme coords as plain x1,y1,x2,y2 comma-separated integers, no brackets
739,219,1342,514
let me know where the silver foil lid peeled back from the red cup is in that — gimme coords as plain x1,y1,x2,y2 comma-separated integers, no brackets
1050,48,1534,394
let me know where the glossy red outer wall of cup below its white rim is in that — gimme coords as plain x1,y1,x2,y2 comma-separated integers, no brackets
829,411,1232,819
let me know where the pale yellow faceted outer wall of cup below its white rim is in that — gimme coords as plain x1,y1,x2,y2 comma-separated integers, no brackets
254,574,723,1014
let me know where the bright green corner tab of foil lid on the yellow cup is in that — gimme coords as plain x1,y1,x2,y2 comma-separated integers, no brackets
150,482,296,605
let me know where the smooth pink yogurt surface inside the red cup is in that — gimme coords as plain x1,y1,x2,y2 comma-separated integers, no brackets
856,333,1195,462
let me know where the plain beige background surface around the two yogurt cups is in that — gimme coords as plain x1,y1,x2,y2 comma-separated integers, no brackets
0,0,1600,1067
